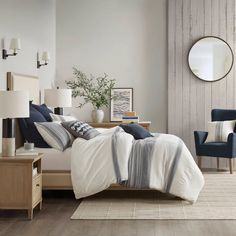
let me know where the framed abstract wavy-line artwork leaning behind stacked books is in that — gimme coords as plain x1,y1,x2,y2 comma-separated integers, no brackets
110,88,133,121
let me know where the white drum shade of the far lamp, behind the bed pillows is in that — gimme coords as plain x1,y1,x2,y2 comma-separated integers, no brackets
44,89,72,107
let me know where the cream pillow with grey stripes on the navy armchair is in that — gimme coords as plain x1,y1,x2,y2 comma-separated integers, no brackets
205,120,236,143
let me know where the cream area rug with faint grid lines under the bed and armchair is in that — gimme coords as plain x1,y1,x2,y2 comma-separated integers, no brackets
71,174,236,220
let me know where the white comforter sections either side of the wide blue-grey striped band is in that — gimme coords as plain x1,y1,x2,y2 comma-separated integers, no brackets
71,128,204,202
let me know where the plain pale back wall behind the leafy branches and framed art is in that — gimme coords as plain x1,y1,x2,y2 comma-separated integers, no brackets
56,0,167,132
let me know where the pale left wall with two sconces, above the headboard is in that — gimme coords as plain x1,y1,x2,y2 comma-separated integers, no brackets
0,0,56,151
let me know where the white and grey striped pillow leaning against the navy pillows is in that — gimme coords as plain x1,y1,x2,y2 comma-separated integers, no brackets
35,122,74,151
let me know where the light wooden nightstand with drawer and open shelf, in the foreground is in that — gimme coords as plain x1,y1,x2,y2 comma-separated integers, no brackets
0,154,43,219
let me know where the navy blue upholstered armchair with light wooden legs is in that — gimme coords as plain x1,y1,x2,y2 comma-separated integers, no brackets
194,109,236,174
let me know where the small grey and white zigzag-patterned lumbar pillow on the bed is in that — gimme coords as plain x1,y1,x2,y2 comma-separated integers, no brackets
62,121,100,140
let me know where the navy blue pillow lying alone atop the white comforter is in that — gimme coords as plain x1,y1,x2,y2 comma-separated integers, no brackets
120,124,153,139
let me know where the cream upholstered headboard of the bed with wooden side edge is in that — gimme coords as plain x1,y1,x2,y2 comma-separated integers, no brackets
7,72,40,148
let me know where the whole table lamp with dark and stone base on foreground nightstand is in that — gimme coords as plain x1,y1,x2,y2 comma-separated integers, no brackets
0,91,29,157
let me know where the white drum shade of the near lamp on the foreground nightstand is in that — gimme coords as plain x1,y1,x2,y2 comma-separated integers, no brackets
0,91,29,119
